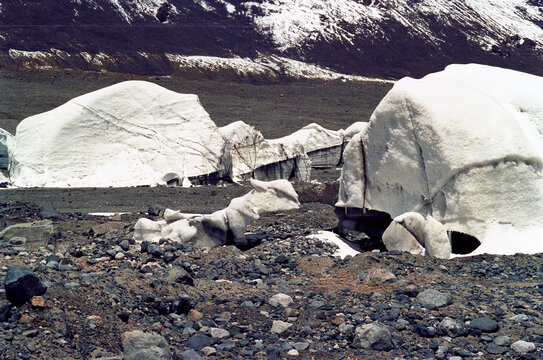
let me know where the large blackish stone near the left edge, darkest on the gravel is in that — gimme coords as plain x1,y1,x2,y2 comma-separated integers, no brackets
4,265,47,306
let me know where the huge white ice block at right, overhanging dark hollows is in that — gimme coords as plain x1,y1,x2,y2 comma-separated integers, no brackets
337,64,543,254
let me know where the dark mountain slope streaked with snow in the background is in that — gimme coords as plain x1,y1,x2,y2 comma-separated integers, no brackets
0,0,543,78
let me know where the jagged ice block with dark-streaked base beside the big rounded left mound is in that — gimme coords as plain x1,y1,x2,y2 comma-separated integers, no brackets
220,121,311,181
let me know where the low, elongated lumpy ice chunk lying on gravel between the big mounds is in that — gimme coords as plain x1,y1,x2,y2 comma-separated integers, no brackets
134,179,300,247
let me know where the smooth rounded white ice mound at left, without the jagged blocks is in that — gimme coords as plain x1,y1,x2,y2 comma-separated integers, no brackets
9,81,229,187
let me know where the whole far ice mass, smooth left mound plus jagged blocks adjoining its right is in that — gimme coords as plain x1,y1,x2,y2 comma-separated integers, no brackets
6,81,346,187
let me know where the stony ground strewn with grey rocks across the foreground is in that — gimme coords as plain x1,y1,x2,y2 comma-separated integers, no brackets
0,69,543,360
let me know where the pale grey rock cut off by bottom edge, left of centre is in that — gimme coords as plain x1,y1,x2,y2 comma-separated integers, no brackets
121,330,172,360
